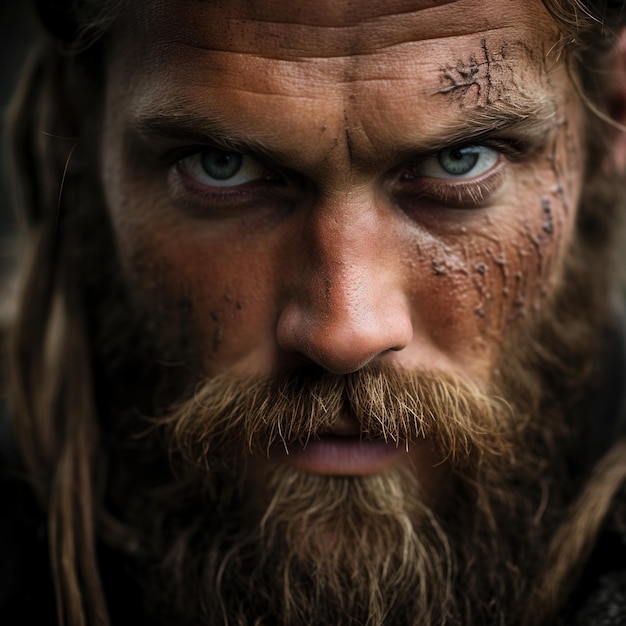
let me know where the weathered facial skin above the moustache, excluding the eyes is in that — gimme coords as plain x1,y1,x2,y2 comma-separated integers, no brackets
101,0,583,478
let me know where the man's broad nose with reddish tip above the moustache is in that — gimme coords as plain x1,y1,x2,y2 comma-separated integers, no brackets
277,193,413,374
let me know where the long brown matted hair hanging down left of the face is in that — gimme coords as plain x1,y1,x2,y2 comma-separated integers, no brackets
8,44,107,626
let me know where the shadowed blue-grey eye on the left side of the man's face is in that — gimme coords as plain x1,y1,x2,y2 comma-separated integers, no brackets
178,148,270,187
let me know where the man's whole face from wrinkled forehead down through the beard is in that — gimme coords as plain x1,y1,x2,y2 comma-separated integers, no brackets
83,0,600,624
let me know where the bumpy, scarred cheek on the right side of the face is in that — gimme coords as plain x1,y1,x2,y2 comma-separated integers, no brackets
407,125,581,376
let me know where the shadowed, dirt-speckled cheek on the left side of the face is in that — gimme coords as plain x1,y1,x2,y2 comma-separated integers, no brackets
111,218,282,373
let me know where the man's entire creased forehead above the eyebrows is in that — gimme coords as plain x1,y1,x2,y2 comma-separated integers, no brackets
108,0,557,168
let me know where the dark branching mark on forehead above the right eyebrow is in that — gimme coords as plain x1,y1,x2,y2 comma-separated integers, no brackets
438,39,523,107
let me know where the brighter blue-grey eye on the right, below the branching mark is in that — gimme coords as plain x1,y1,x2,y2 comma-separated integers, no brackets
414,145,499,179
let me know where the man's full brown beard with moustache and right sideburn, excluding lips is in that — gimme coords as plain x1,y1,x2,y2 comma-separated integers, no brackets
101,250,599,626
